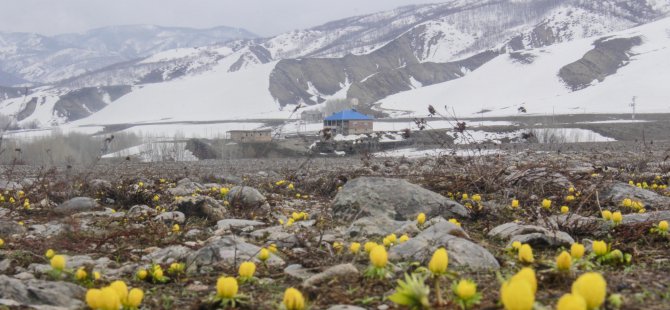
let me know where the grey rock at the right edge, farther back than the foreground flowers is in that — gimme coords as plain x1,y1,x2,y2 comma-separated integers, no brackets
601,182,670,210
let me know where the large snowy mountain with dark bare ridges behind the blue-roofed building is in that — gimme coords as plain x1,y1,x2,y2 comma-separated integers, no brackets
0,0,670,126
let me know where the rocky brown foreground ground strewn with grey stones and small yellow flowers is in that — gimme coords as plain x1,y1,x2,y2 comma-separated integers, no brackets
0,143,670,309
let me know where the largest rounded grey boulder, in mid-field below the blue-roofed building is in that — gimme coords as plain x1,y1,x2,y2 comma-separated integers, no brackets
332,177,469,221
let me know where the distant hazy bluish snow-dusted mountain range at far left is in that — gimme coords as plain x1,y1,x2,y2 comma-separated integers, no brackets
0,25,256,86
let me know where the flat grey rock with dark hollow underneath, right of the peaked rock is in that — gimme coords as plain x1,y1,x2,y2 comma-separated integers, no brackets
488,223,575,247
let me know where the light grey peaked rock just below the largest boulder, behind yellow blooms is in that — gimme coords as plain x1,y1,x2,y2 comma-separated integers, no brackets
389,222,500,269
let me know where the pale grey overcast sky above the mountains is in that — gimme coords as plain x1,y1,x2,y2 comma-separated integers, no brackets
0,0,440,36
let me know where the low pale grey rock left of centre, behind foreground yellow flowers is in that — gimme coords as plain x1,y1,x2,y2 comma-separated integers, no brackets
187,237,284,268
